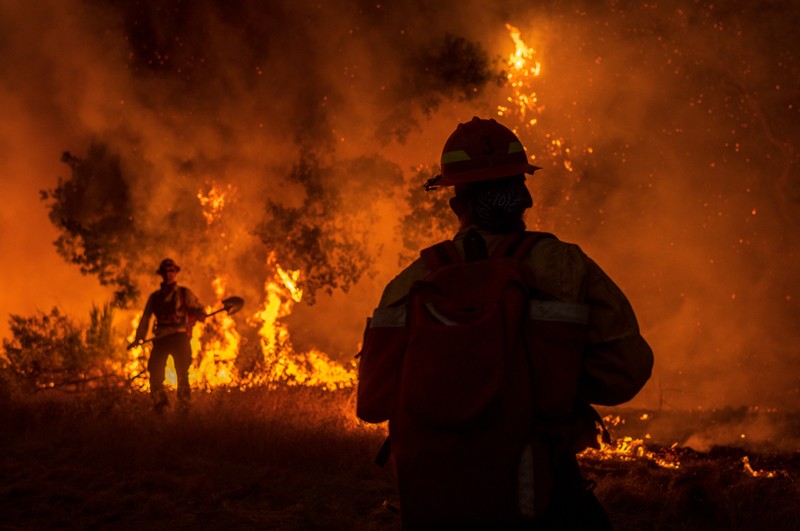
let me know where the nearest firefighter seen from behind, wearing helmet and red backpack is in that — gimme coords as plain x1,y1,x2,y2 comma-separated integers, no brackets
357,118,653,529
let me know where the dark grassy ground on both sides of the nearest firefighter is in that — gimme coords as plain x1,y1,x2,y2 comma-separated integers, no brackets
0,388,800,530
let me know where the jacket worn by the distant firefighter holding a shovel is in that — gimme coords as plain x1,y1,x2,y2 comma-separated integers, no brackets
136,283,205,340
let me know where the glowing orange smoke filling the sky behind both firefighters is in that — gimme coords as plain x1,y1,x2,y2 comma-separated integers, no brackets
0,0,800,407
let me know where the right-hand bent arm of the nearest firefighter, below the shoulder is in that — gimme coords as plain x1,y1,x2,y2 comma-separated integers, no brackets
580,258,653,406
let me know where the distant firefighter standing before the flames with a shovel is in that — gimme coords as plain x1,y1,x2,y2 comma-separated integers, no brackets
134,258,206,412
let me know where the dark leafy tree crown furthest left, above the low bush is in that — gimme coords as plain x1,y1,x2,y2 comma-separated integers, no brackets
41,143,140,307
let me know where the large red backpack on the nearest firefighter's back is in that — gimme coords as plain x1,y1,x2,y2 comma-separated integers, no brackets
358,232,552,525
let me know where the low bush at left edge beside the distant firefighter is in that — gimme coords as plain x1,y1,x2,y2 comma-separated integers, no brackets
3,304,125,392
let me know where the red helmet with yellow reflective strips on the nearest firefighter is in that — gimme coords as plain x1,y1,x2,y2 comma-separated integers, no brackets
425,116,541,190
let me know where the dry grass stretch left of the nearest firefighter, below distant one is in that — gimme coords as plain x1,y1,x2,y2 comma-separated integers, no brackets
0,389,397,529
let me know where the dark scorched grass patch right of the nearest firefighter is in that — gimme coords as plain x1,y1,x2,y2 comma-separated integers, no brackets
583,451,800,531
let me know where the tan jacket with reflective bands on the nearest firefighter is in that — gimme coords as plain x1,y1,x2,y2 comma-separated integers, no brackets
357,227,653,522
